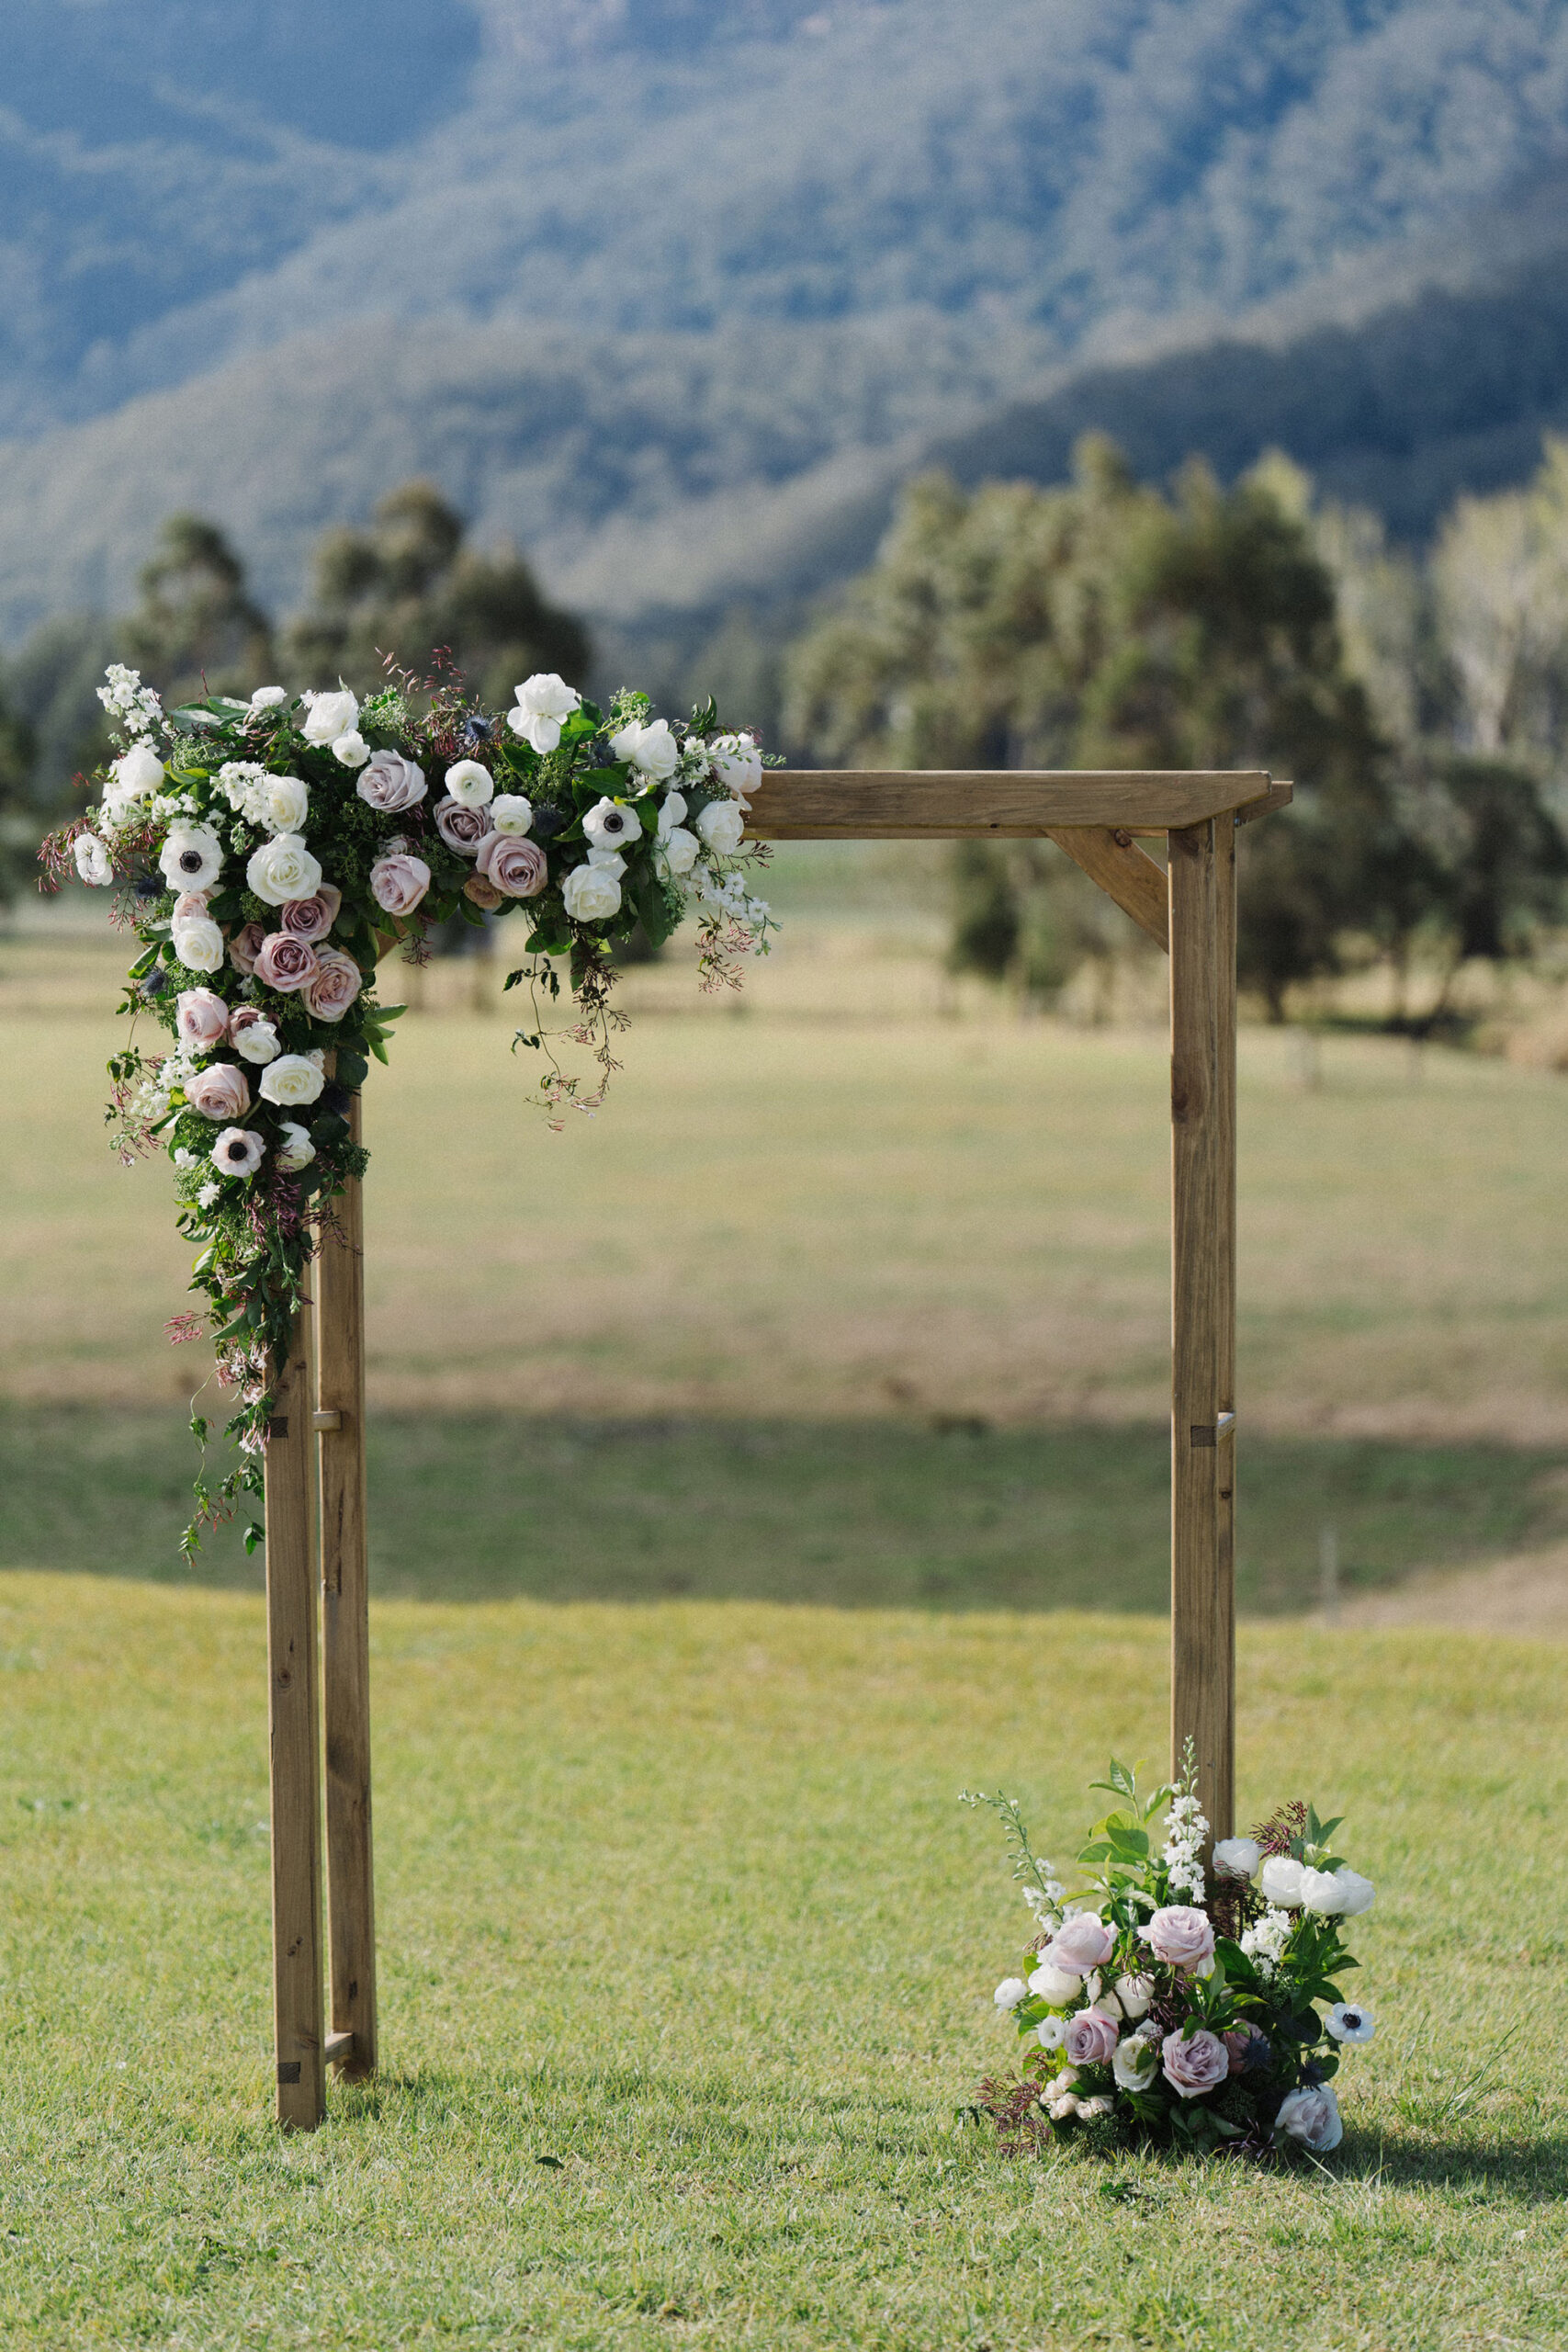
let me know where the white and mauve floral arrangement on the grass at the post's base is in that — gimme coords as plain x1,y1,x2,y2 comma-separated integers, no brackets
964,1747,1373,2159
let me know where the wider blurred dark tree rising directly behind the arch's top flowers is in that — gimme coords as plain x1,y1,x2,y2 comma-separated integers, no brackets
285,482,590,708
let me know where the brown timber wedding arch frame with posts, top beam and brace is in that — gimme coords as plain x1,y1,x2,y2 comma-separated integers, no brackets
265,769,1291,2131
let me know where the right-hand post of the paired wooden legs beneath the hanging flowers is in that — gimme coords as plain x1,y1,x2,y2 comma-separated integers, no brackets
315,1093,376,2079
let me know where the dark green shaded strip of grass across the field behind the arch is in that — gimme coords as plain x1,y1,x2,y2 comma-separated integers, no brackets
0,1407,1563,1613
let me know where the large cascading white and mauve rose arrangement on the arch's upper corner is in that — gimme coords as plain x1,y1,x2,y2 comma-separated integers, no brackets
42,665,773,1547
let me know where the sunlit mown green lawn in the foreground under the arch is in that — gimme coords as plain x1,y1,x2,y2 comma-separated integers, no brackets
0,1574,1568,2352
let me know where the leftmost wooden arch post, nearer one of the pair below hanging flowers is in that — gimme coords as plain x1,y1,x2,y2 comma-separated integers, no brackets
265,1310,327,2131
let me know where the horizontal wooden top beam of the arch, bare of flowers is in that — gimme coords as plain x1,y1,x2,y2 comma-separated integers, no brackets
745,767,1269,842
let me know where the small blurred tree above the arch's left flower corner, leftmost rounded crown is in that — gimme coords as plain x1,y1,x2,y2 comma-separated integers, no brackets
118,515,273,703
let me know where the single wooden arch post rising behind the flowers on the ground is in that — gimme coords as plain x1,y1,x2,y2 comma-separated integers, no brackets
1170,816,1236,1837
